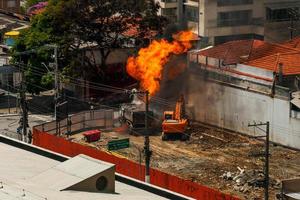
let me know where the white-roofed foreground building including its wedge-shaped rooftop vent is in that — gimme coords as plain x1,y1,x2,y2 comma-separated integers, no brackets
0,136,192,200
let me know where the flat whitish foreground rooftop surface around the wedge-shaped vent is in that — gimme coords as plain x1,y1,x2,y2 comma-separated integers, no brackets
0,136,188,200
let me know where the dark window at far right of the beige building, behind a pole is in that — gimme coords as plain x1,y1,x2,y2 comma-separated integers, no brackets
266,7,299,22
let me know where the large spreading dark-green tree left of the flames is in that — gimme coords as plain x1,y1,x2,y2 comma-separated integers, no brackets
14,0,166,94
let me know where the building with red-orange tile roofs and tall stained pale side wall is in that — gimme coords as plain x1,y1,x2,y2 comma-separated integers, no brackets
186,38,300,149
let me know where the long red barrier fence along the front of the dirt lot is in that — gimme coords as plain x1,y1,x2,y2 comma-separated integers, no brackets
33,128,238,200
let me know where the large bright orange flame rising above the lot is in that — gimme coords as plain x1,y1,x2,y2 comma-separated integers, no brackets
126,31,194,96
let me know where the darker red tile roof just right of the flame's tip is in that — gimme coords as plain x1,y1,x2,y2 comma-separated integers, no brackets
199,40,265,64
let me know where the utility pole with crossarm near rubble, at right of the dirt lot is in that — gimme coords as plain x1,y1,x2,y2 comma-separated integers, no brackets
248,121,270,200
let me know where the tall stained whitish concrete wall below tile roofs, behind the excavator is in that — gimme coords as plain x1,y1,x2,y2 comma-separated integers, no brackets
186,67,300,149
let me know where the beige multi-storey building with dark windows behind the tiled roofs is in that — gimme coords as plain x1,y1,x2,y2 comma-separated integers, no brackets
158,0,300,44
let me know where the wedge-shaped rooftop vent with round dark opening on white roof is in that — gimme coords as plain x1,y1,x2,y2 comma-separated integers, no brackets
29,155,115,193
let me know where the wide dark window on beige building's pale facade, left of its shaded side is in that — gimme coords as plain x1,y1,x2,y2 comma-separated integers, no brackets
217,10,252,26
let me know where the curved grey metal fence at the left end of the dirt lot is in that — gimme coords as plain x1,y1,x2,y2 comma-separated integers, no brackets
34,109,119,135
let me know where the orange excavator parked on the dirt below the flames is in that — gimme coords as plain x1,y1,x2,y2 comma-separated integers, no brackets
162,95,189,140
